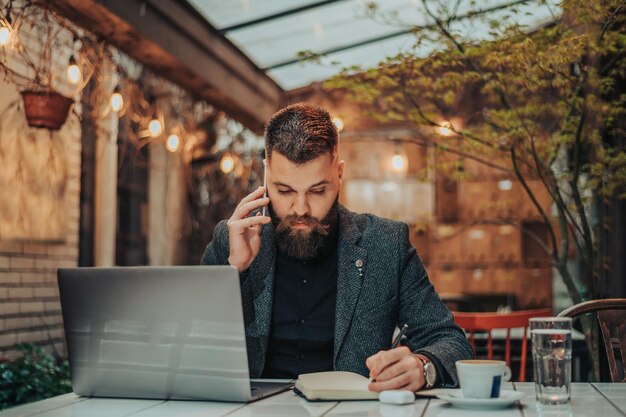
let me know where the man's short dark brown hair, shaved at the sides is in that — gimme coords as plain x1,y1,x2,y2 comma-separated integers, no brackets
265,103,339,164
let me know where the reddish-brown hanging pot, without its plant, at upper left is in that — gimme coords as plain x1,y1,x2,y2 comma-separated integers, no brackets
22,90,74,130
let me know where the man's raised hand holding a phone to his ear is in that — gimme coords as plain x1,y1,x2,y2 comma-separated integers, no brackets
226,187,272,272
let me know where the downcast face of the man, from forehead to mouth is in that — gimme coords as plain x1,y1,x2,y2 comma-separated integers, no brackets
267,151,344,229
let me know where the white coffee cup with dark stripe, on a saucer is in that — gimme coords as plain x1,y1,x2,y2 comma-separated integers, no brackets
456,359,511,398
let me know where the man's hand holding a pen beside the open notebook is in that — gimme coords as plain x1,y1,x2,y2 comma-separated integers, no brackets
365,346,426,392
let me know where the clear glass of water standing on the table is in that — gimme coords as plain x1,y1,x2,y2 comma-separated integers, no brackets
530,317,572,404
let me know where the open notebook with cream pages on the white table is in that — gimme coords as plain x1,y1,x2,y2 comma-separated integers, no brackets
294,371,378,401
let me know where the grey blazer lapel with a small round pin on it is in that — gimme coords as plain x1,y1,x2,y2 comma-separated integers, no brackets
333,206,367,362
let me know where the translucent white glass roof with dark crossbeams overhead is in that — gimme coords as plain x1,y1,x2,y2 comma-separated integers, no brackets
187,0,561,90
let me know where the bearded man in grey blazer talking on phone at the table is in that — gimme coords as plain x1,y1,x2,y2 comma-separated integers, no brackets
202,103,472,391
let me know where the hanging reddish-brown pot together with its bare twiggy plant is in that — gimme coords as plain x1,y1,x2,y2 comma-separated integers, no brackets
0,1,98,130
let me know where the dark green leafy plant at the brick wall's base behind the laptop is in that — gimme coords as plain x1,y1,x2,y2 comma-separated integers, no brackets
0,343,72,410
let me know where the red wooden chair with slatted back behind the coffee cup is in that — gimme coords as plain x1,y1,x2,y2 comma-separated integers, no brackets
452,308,552,382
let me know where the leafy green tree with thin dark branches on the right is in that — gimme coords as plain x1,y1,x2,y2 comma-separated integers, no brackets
327,0,626,308
